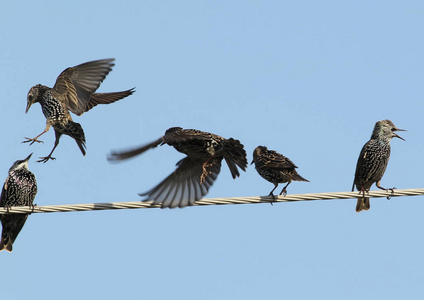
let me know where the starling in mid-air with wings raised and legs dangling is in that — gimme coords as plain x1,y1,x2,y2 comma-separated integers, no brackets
23,58,134,163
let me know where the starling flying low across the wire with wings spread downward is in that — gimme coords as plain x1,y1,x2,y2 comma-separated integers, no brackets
108,127,247,208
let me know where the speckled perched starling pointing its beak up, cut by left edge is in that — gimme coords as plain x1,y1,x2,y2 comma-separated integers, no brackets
0,153,37,252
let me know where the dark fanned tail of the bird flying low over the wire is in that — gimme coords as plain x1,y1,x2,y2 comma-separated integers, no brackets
224,138,247,179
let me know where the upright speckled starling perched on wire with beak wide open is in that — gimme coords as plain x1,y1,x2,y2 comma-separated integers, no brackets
352,120,405,212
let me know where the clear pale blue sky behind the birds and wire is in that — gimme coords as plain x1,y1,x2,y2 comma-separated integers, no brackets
0,0,424,299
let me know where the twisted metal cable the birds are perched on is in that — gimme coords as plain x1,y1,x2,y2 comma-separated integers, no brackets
0,188,424,214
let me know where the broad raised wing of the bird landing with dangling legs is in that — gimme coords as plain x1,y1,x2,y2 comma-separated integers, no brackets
52,58,118,116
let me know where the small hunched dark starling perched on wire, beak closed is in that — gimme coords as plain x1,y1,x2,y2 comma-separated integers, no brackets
252,146,309,199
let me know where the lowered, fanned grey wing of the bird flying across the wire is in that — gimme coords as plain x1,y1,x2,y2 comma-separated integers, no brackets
140,157,222,208
